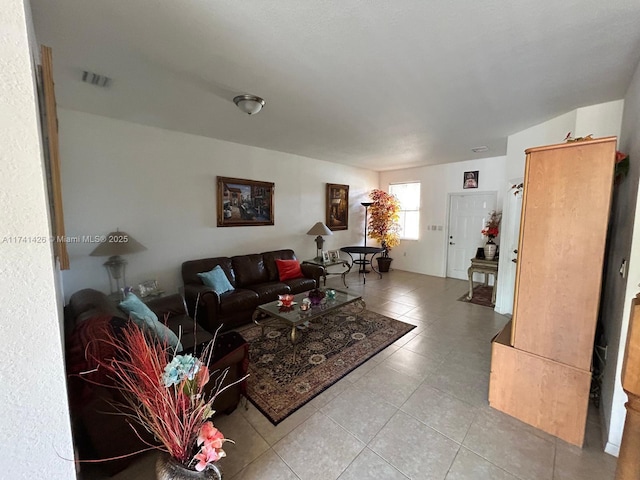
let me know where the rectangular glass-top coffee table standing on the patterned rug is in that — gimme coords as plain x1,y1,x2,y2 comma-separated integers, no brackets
253,290,366,362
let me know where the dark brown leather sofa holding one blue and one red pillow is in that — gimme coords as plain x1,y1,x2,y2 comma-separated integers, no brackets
182,250,323,332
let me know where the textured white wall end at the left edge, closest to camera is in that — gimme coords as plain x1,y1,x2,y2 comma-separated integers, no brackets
0,0,75,480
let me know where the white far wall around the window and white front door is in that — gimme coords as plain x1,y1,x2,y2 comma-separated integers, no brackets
380,157,506,277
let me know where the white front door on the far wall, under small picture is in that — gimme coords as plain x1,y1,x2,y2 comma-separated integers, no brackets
447,192,497,280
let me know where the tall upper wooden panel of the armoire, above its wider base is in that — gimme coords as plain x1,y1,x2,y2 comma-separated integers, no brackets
512,137,616,370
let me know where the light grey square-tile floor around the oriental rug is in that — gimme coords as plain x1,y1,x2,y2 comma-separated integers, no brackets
85,271,616,480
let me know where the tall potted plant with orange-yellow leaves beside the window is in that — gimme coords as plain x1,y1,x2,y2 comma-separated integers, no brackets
368,189,401,272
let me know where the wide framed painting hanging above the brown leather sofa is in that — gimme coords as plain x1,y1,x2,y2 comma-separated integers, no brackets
217,177,274,227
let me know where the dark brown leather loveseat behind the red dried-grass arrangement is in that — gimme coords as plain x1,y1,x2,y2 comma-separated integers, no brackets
65,289,248,473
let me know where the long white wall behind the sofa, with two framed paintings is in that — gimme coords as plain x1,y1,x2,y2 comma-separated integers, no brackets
58,109,378,298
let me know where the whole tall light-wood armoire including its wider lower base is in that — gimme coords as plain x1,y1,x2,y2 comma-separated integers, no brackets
489,137,616,446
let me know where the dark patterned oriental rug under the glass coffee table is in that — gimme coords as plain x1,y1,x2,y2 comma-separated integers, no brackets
241,304,415,425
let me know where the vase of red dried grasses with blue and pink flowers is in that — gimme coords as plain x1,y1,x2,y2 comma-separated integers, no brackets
91,322,246,480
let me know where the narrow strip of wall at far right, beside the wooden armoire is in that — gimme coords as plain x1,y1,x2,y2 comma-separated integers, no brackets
601,69,640,455
